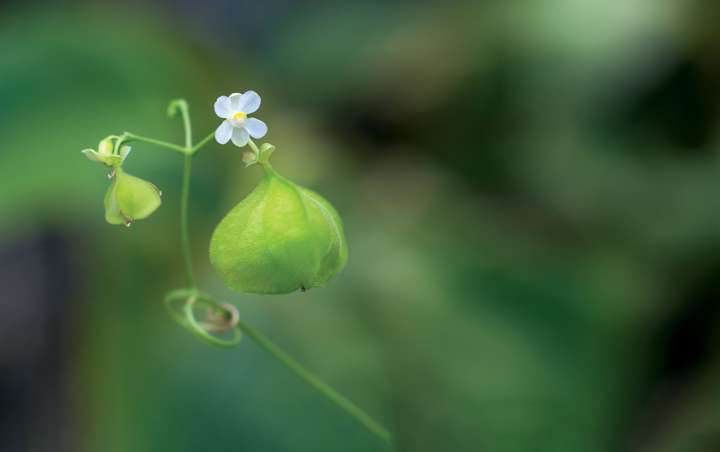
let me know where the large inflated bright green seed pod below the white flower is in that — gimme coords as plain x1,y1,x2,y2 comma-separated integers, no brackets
210,164,348,294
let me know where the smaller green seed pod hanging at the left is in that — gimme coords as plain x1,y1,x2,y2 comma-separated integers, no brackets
105,167,162,226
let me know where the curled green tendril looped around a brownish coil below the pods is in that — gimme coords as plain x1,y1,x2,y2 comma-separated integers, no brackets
165,289,242,347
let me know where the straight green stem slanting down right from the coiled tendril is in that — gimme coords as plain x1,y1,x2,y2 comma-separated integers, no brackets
238,320,391,443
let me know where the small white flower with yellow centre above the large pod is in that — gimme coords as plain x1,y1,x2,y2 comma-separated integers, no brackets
215,91,267,147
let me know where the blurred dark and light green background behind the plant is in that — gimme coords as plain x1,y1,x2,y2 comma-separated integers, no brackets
0,0,720,452
